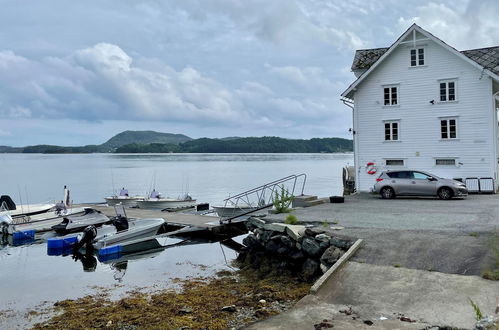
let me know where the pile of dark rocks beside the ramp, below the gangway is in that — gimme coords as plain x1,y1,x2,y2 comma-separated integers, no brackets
239,217,354,281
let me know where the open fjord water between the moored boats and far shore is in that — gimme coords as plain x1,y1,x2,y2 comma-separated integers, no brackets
0,154,353,204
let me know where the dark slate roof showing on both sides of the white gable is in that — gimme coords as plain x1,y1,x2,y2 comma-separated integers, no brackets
352,46,499,75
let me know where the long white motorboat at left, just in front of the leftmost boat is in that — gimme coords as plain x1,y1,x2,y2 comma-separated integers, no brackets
3,207,86,234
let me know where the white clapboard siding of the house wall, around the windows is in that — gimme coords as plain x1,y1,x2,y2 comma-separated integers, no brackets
354,41,497,191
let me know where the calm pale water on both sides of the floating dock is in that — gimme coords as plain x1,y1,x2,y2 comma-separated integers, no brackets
0,154,353,328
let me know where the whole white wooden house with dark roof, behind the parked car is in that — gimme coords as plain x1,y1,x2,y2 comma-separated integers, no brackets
341,24,499,191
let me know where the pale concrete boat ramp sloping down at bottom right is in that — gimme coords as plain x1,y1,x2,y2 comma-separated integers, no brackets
250,262,499,329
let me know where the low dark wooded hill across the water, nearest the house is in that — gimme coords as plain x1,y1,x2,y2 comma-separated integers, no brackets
116,136,353,153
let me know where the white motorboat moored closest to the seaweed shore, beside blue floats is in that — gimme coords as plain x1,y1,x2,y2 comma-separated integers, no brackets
93,218,165,249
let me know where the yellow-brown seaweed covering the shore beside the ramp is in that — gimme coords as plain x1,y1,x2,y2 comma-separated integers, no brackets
34,269,310,329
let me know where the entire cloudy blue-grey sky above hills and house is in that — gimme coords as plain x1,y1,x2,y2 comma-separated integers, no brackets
0,0,499,146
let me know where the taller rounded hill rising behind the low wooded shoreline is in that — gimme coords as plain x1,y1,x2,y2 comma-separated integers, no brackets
99,131,192,152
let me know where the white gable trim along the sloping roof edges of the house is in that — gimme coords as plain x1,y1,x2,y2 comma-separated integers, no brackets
341,23,499,100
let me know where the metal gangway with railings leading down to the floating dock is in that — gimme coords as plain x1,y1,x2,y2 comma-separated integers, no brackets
220,173,307,224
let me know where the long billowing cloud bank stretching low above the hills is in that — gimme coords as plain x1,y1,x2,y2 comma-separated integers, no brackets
0,43,343,135
